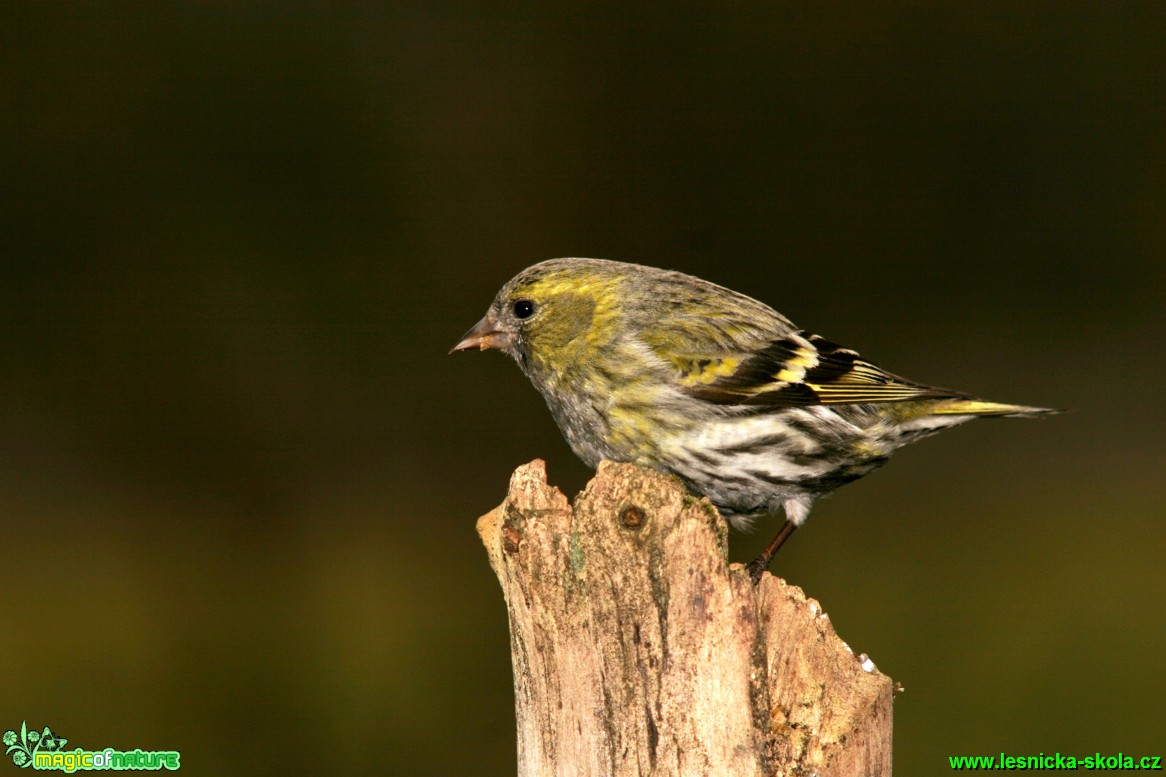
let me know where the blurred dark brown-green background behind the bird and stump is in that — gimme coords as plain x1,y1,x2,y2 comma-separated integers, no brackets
0,2,1166,776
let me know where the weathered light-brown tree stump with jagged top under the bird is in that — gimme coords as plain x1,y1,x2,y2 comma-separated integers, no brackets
478,460,892,777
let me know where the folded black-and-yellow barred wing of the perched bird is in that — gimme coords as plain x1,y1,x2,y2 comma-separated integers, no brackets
672,331,967,407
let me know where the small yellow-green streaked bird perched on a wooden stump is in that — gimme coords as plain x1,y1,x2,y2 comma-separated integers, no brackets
450,258,1059,583
